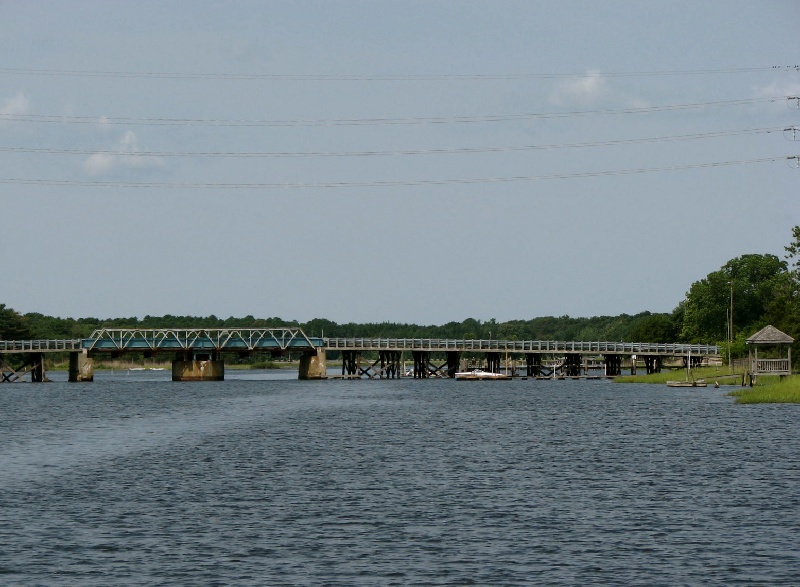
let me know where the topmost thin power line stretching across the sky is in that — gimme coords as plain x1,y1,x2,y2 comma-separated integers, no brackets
0,66,796,82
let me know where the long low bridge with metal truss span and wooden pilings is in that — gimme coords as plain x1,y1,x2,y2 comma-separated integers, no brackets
0,327,720,382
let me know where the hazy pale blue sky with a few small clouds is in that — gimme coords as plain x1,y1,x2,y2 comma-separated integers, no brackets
0,0,800,324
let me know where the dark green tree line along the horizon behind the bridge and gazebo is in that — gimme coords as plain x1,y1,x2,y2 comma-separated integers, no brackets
0,226,800,366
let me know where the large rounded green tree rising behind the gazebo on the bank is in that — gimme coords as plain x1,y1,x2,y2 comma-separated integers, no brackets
681,254,787,342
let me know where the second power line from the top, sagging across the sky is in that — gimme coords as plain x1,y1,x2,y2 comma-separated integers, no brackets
0,96,785,127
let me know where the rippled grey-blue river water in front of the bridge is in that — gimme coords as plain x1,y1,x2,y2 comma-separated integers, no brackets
0,372,800,586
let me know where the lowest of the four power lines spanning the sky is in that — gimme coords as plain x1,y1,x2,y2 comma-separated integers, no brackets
0,156,784,190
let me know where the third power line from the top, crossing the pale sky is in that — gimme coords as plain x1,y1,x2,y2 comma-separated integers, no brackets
0,127,786,158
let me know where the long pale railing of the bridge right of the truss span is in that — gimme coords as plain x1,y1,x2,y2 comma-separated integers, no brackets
325,338,720,356
